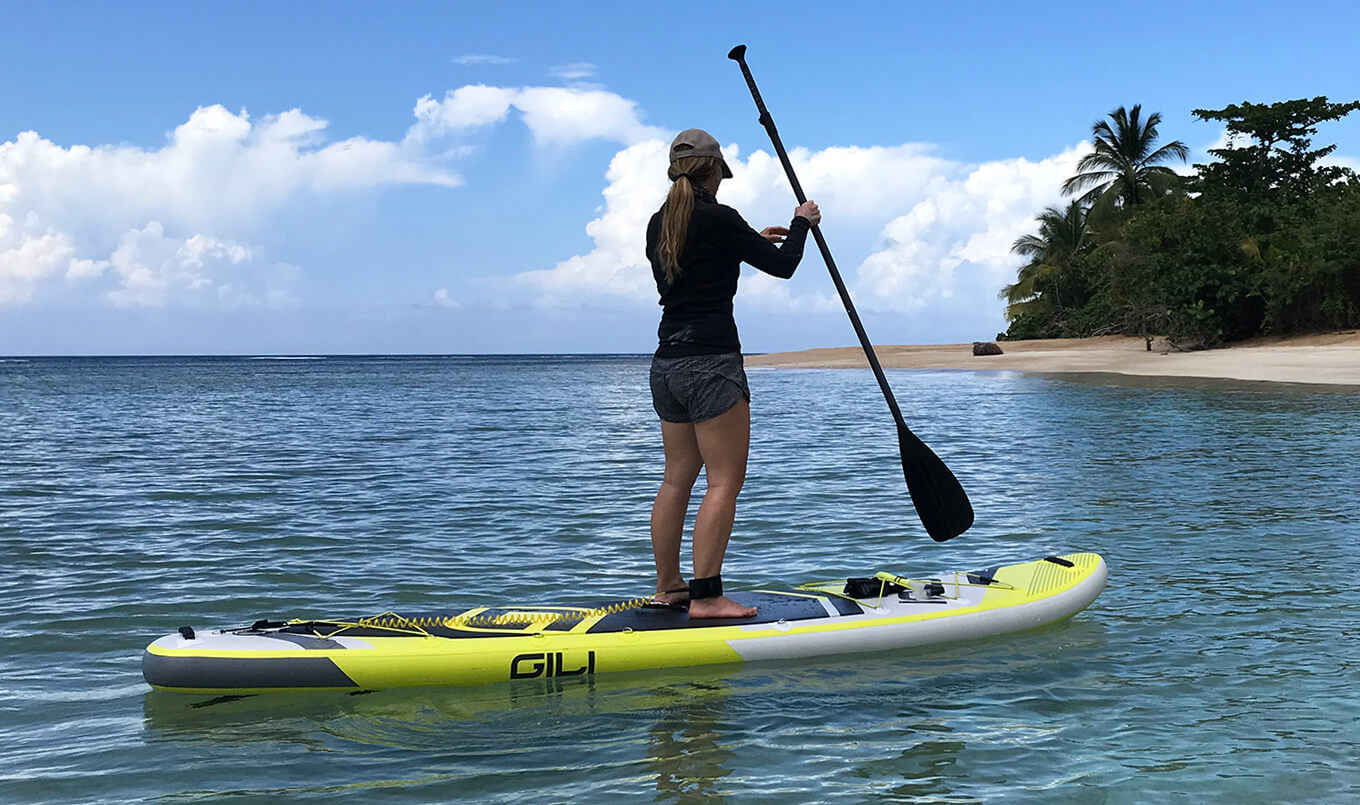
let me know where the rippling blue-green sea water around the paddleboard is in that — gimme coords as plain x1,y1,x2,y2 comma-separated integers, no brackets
0,358,1360,802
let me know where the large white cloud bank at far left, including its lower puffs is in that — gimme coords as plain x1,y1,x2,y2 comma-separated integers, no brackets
0,106,460,306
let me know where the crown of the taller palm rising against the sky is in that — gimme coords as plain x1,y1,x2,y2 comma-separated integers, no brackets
1062,103,1190,208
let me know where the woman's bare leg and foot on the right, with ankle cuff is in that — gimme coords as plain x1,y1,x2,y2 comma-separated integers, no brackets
690,400,756,617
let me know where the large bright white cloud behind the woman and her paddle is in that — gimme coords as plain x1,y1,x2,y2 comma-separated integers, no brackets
515,139,1087,311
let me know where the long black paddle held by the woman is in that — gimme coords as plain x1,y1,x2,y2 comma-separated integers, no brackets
728,45,972,543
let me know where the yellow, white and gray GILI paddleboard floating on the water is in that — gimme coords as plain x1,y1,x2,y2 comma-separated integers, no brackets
141,553,1107,693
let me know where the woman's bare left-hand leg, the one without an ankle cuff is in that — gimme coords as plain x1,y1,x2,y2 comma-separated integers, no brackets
651,420,703,602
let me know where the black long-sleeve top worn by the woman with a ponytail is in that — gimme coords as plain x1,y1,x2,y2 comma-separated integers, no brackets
647,188,811,358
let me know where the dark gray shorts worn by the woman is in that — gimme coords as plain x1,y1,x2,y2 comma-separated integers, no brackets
651,352,751,422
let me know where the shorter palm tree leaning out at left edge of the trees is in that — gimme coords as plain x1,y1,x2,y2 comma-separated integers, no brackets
997,200,1089,321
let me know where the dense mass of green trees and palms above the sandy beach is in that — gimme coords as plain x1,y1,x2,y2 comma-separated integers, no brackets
1001,98,1360,348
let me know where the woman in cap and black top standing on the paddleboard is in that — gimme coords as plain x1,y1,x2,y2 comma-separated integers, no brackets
647,129,821,617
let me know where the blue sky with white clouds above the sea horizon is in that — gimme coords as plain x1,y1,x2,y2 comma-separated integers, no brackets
0,0,1360,355
